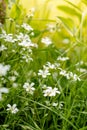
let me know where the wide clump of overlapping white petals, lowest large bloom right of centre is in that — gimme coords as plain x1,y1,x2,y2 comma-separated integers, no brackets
43,86,60,97
